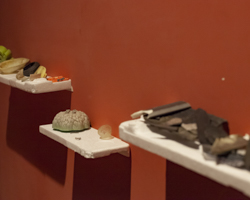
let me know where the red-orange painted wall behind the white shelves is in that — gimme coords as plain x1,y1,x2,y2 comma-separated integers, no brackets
0,0,250,200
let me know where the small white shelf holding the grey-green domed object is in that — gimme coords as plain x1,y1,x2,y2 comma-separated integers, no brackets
39,124,129,158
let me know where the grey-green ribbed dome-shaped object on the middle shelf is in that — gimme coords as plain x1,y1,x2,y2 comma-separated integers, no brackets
52,109,90,132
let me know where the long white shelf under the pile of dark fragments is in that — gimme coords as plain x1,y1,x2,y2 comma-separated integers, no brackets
119,119,250,197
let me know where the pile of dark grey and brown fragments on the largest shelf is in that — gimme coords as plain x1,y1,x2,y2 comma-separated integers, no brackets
140,102,250,170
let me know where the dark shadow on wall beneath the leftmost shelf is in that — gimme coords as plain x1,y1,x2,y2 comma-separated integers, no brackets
6,88,71,184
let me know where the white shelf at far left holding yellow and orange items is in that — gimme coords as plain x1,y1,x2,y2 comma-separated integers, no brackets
0,74,73,94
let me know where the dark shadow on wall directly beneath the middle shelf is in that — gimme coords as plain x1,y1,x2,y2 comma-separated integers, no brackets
73,153,131,200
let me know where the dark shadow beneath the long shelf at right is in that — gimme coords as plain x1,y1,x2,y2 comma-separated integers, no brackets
166,161,250,200
